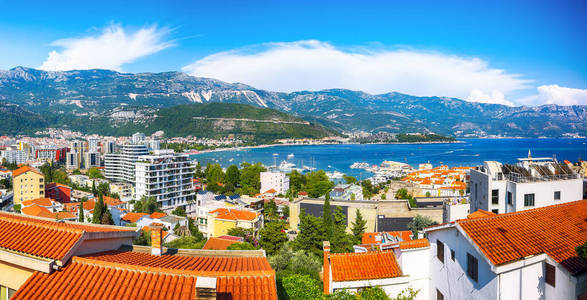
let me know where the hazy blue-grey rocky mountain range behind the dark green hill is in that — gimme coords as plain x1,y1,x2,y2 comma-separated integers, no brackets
0,67,587,137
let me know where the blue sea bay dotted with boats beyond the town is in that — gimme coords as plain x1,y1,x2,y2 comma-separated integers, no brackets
191,138,587,178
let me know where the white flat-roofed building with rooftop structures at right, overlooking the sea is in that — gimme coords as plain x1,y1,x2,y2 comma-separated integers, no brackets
469,155,583,214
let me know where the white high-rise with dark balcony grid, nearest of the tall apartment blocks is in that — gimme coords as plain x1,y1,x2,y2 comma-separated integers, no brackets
134,150,195,210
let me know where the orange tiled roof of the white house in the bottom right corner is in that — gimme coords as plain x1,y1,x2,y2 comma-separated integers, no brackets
456,200,587,274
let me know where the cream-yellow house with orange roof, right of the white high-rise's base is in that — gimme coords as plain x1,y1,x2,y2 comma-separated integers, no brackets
207,208,263,237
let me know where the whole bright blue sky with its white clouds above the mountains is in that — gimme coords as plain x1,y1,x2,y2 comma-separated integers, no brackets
0,0,587,105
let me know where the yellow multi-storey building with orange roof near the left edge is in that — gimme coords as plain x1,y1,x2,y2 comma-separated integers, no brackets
12,166,45,205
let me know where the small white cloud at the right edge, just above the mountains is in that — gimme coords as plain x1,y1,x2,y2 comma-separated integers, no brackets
519,84,587,105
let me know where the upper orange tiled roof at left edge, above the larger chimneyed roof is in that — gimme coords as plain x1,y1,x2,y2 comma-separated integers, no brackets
0,212,130,260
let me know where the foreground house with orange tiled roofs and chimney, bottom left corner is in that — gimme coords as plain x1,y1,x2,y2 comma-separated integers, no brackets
0,212,277,300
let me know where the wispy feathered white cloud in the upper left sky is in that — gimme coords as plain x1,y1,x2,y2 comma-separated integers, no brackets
40,25,173,71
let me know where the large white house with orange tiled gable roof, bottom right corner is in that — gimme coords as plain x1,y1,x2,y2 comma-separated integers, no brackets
425,200,587,300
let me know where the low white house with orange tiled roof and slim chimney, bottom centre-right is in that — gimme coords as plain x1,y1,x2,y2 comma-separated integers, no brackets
323,239,430,299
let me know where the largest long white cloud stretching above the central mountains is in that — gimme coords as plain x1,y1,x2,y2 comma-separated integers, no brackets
183,41,530,104
